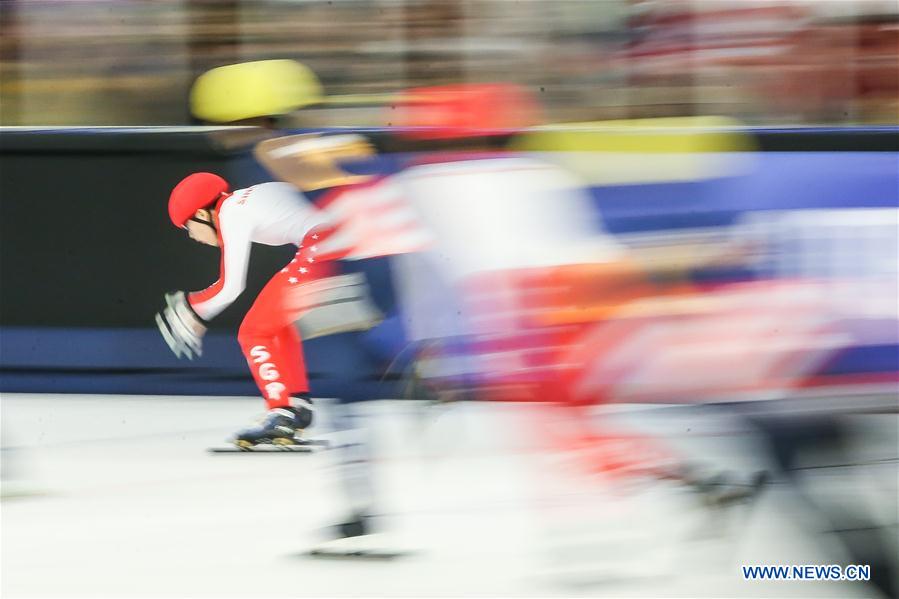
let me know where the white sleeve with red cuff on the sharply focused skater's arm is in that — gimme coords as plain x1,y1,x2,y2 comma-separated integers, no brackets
188,210,252,320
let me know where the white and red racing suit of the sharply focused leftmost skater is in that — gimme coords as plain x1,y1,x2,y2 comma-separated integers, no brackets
188,179,420,408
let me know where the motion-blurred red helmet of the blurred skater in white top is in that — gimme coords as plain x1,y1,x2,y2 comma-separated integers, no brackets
393,83,540,139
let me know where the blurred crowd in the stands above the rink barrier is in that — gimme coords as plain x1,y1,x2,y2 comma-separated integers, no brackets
0,0,899,126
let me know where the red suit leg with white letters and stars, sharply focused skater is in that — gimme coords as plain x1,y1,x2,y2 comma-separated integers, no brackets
237,229,339,409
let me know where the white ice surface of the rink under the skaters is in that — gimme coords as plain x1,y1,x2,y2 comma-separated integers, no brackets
0,394,896,598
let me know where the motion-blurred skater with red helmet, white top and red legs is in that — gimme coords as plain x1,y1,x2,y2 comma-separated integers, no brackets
386,85,758,492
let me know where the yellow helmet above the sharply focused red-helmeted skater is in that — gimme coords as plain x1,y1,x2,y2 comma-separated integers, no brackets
190,60,322,123
